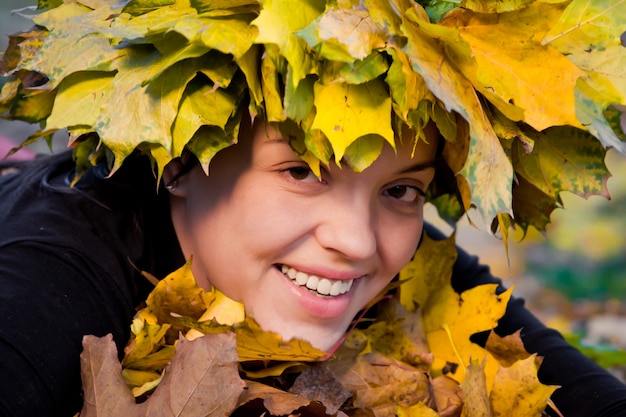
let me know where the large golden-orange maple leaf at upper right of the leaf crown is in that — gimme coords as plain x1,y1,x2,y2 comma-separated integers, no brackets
440,2,584,130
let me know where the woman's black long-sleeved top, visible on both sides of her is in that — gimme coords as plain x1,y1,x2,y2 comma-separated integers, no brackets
0,153,626,417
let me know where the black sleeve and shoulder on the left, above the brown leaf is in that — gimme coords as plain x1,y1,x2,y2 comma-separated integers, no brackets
0,155,155,417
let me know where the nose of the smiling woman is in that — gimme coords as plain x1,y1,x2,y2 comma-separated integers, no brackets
316,193,378,260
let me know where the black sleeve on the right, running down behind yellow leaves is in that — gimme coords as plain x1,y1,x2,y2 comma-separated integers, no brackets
425,225,626,417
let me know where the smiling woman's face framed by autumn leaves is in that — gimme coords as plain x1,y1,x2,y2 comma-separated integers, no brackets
171,123,435,350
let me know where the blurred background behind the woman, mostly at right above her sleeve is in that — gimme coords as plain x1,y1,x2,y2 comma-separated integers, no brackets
0,0,626,380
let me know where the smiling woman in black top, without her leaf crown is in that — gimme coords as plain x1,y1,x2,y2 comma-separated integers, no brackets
0,116,626,416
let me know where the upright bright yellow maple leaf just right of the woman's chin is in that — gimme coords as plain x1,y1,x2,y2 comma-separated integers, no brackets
400,235,512,390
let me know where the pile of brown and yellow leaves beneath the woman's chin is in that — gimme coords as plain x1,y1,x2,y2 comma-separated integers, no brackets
80,237,557,417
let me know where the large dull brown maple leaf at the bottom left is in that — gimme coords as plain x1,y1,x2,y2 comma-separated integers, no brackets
80,333,245,417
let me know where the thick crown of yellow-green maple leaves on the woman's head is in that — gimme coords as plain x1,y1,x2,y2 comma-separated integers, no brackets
0,0,626,238
